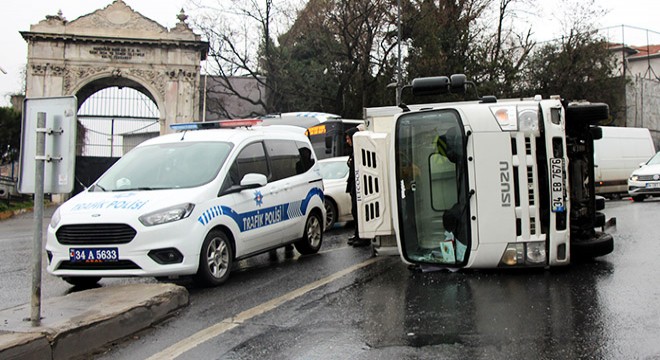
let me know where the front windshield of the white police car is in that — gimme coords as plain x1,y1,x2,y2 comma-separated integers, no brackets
92,141,232,191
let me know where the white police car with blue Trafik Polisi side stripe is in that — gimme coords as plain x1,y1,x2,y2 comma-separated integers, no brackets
46,122,325,286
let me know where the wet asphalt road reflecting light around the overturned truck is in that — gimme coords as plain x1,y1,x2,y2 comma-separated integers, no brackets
0,199,660,359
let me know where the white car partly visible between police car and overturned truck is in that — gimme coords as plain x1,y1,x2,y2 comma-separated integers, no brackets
319,156,353,230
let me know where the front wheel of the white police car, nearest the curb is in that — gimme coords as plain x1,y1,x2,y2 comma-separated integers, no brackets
195,230,233,286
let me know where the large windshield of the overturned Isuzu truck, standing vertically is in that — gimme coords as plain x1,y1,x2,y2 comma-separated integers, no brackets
395,110,470,267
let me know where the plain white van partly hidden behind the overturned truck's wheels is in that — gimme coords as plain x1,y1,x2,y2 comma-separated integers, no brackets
594,126,655,197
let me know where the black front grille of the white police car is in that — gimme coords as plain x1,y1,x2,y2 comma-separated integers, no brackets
55,224,136,245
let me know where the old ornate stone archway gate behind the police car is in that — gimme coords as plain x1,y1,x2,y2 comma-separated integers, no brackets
21,0,208,134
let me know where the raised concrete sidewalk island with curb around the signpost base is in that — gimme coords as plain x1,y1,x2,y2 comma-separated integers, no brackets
0,284,188,360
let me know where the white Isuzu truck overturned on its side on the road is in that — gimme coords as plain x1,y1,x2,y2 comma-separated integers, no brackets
354,74,613,269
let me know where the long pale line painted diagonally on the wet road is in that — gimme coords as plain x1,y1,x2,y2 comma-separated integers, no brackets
147,257,383,360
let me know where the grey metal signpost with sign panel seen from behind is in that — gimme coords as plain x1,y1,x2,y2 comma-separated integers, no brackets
18,96,78,326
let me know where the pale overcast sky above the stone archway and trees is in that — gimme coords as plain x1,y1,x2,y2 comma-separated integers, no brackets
0,0,660,106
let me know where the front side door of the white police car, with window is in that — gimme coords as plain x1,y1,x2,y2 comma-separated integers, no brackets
223,141,280,253
